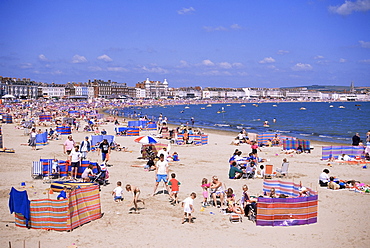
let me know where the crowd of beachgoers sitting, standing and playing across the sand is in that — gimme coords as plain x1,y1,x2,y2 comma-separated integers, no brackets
1,98,370,226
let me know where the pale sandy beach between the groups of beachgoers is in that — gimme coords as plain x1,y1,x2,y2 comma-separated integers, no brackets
0,118,370,248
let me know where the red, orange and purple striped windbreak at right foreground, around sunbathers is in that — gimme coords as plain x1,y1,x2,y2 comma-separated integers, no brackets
256,179,318,226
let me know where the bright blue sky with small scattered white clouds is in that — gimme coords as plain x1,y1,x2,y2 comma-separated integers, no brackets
0,0,370,87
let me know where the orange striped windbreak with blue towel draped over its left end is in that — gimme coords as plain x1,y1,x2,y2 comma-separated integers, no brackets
9,185,102,231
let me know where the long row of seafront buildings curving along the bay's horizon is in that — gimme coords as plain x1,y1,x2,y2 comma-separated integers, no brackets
0,77,370,101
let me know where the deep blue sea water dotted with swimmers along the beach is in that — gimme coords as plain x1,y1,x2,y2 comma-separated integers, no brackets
115,102,370,144
